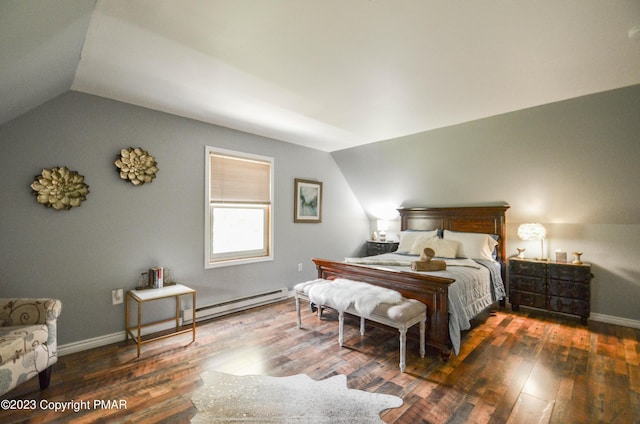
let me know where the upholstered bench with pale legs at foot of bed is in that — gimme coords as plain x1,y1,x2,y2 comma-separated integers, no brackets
294,279,427,372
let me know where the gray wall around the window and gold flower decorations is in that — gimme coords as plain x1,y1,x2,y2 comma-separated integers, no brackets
0,92,369,344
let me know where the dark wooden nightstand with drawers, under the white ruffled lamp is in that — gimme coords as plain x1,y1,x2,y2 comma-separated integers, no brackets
509,258,593,325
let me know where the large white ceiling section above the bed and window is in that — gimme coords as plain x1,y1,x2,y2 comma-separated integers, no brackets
0,0,640,151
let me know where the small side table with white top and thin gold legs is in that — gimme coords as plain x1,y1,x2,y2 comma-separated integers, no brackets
125,284,196,357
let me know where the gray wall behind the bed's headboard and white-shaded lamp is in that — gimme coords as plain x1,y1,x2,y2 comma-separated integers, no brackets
333,86,640,321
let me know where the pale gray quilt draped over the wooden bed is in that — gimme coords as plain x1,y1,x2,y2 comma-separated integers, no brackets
346,253,506,354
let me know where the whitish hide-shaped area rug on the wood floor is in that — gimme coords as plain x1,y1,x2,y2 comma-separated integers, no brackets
191,371,402,424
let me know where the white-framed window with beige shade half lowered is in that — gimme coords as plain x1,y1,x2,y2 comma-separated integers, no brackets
205,147,273,268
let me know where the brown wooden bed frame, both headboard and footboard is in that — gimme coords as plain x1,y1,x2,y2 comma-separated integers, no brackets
313,205,509,361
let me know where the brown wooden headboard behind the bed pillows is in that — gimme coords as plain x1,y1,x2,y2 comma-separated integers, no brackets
398,205,509,281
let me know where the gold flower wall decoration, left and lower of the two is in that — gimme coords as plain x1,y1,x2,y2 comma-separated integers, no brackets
31,166,89,211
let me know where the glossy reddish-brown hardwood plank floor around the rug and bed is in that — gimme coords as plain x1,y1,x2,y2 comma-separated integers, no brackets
0,299,640,424
